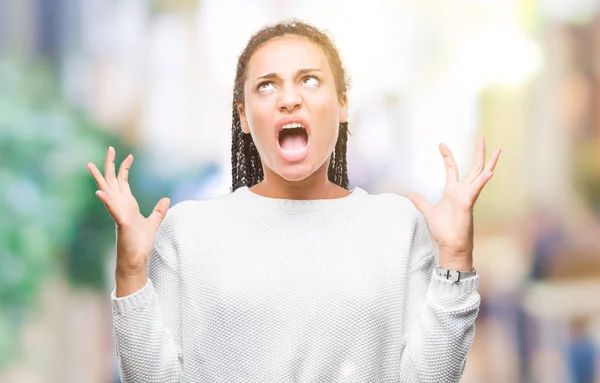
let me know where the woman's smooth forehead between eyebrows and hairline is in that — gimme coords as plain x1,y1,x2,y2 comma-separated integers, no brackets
247,36,329,79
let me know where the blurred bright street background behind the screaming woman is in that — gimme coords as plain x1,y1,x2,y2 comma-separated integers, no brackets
0,0,600,383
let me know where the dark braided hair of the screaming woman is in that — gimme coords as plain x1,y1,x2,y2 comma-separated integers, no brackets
231,20,349,192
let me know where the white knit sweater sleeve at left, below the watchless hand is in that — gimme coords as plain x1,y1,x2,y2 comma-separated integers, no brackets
112,220,182,383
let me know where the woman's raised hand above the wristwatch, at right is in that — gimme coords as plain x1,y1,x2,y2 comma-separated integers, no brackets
408,138,501,271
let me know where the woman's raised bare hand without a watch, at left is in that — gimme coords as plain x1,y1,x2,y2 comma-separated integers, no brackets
86,146,170,296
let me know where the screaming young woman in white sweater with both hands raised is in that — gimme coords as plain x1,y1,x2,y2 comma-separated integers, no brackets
87,21,500,383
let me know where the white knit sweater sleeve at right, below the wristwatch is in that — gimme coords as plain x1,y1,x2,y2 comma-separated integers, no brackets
400,214,480,383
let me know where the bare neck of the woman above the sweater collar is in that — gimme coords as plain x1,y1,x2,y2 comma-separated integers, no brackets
250,162,350,200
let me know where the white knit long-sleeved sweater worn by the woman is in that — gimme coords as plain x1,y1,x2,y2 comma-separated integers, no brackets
112,187,480,383
